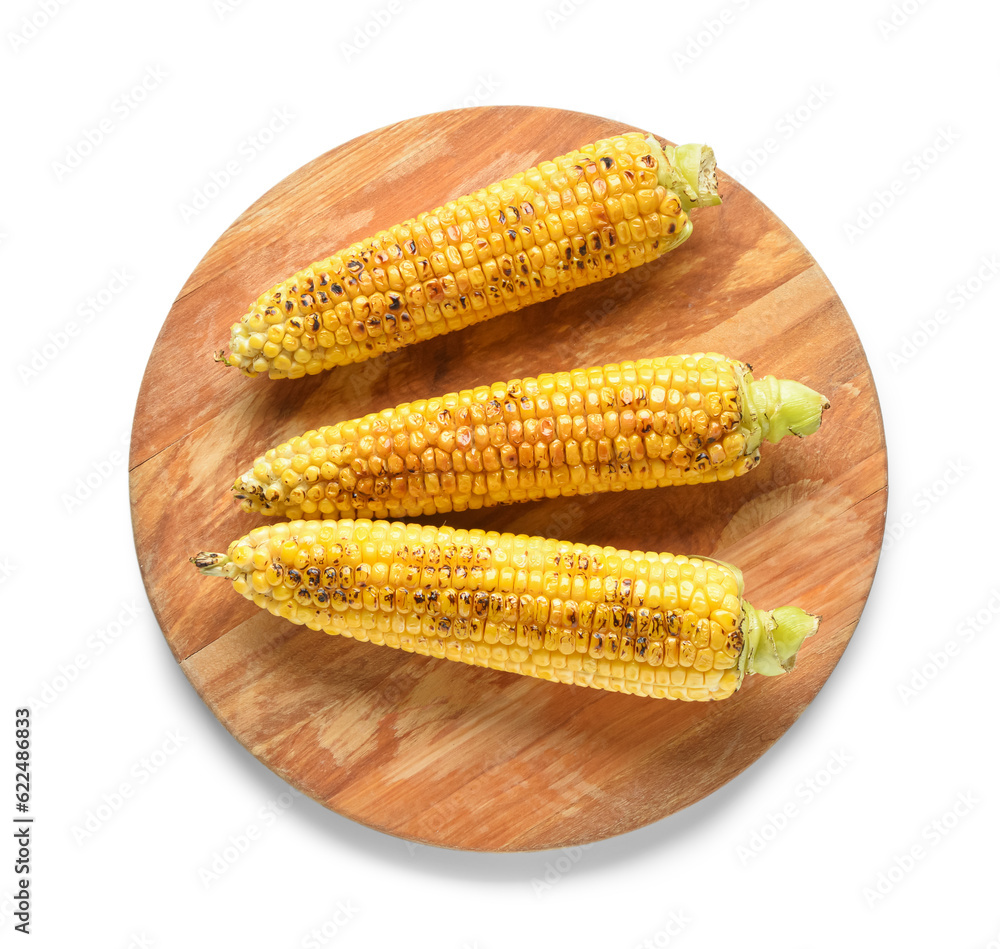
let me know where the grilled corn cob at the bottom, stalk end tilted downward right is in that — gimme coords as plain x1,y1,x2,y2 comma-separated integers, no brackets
191,519,818,701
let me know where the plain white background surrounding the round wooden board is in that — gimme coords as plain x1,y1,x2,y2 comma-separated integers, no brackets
0,0,1000,949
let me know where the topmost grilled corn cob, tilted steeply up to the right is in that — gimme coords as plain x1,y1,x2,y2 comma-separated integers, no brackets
216,132,719,379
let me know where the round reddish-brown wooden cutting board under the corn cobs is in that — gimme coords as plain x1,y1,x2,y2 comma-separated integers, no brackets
130,107,887,851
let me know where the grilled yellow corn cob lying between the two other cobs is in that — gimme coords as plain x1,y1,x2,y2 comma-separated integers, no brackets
233,353,829,519
